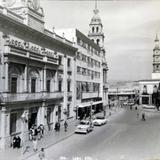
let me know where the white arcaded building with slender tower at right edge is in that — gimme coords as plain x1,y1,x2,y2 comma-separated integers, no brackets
139,35,160,105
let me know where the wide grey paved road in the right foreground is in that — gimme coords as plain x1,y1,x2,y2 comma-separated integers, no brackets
27,109,160,160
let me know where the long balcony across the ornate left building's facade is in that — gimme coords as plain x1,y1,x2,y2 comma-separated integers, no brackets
0,92,63,103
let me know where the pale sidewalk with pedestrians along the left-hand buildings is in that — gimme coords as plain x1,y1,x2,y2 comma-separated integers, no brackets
0,108,120,160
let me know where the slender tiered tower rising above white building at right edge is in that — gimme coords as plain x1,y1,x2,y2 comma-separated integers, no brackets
152,34,160,79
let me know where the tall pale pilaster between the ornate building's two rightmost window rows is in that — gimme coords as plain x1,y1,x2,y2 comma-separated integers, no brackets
62,55,67,120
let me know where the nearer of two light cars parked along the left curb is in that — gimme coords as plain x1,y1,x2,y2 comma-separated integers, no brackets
75,120,94,134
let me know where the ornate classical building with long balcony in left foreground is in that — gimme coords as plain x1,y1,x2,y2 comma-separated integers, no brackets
0,0,77,148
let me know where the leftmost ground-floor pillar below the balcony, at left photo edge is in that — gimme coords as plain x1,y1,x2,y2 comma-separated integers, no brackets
0,107,7,149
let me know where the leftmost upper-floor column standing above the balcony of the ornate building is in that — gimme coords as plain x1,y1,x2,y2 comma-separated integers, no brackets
4,57,9,92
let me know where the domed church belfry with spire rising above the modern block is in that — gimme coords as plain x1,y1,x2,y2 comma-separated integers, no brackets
88,1,104,48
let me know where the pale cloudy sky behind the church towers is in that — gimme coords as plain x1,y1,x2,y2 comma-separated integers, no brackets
41,0,160,81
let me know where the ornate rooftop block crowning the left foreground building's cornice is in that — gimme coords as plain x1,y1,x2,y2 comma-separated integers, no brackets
1,0,44,32
